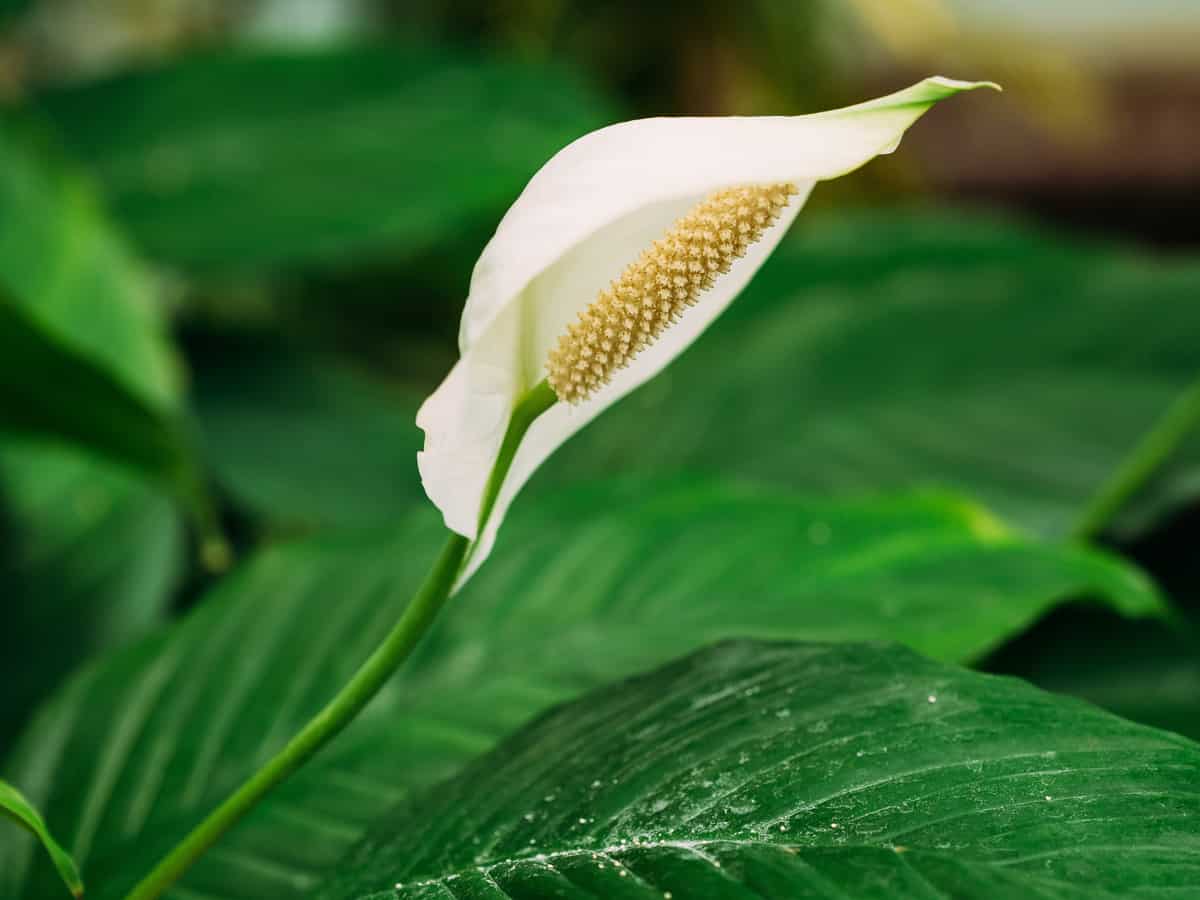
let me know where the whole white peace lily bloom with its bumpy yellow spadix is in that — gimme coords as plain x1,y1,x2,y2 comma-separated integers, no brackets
416,78,995,584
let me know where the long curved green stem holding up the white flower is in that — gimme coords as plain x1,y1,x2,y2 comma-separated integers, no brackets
126,382,554,900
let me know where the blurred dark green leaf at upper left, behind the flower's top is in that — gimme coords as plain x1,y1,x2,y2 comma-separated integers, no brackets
41,43,612,271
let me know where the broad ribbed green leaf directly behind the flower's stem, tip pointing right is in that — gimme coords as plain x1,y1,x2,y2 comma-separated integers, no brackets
0,481,1157,899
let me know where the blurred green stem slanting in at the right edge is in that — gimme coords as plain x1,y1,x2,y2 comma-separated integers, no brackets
1073,382,1200,539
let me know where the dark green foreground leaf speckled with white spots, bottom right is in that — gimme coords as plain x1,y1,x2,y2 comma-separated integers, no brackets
316,642,1200,900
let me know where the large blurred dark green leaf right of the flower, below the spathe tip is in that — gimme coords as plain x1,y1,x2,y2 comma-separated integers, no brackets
538,212,1200,535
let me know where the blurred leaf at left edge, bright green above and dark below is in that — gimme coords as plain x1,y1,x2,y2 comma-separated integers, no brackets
0,133,211,523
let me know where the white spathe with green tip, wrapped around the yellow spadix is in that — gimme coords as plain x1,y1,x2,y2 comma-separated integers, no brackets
416,78,995,584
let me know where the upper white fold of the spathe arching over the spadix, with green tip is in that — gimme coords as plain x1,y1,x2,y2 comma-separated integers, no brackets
458,78,983,352
